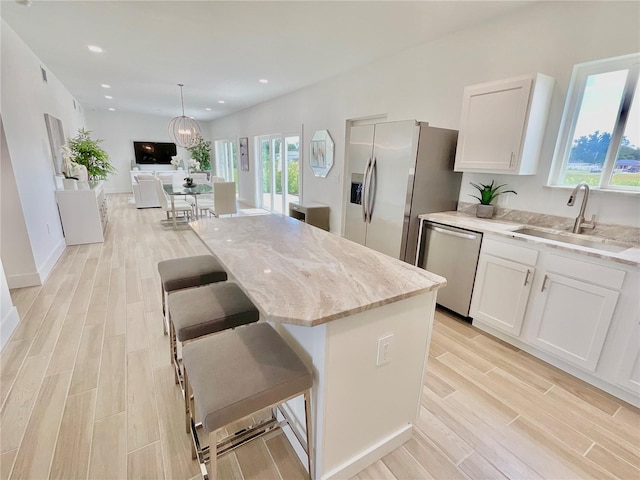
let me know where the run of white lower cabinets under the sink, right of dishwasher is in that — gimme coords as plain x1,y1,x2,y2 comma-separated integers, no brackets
470,234,640,406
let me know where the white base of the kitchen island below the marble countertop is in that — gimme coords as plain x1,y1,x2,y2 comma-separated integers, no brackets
274,292,436,480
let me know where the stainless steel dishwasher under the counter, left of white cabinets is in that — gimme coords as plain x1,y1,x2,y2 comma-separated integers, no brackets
416,220,482,317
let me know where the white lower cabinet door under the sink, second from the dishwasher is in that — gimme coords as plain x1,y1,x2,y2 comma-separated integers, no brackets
531,273,619,371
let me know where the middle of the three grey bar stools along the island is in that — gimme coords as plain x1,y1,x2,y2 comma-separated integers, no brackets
168,282,260,392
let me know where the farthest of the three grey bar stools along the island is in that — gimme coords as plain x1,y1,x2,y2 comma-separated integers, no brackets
158,255,227,335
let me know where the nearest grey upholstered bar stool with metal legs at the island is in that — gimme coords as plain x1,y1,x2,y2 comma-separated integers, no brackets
182,323,313,478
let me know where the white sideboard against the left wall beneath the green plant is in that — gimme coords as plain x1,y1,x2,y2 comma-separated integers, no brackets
56,181,108,245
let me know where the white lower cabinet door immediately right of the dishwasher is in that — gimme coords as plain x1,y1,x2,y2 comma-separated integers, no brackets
471,254,535,336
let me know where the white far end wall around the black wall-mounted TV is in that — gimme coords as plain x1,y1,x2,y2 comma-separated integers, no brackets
86,111,195,193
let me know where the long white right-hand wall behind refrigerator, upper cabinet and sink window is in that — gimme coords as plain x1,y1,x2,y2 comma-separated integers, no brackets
211,2,640,232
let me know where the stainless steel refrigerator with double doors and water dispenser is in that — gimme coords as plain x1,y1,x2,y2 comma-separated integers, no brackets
345,120,462,263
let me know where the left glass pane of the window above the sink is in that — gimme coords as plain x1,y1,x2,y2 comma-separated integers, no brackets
561,70,628,187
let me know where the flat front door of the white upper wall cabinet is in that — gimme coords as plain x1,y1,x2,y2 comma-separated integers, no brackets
455,77,533,173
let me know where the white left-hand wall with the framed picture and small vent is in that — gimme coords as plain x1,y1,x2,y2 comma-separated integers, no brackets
0,20,84,285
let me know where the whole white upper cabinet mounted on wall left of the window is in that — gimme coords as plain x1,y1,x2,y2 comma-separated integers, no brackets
454,73,554,175
